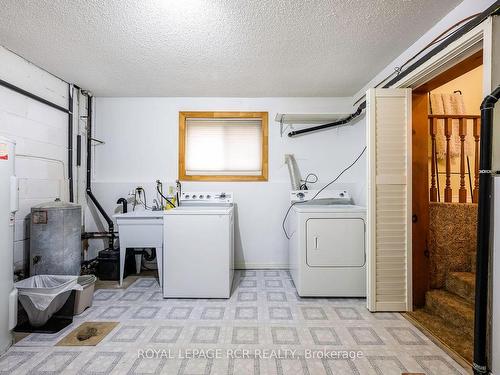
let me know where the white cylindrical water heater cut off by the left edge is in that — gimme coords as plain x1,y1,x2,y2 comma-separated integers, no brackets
0,136,18,354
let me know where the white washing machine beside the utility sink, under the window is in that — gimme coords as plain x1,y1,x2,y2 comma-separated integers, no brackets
163,192,234,298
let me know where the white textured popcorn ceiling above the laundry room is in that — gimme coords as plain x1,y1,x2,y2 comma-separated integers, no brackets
0,0,460,97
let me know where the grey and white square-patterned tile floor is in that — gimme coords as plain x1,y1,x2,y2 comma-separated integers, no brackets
0,270,467,375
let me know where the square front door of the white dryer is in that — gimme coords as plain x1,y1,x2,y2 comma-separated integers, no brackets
306,218,365,267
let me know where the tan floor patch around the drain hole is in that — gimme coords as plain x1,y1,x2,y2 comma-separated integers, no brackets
56,322,118,346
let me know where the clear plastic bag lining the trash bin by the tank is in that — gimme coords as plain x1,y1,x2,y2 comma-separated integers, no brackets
14,275,83,327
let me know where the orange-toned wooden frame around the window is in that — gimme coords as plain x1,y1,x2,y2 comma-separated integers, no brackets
179,112,269,181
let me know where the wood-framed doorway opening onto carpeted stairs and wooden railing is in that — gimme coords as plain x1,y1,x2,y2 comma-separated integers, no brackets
409,50,483,363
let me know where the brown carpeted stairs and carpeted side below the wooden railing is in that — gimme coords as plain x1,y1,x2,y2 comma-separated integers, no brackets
408,202,477,363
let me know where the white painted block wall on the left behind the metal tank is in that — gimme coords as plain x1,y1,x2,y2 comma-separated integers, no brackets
0,46,68,270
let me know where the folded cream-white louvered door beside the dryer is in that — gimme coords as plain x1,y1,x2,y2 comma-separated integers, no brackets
366,89,412,311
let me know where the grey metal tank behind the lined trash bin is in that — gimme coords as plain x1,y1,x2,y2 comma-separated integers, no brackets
30,199,82,276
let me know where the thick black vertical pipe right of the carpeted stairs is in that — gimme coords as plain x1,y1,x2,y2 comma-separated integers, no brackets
472,86,500,375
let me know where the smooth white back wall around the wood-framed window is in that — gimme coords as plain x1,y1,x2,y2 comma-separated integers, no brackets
87,98,365,268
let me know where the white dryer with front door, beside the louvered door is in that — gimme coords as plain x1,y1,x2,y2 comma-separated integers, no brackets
288,190,366,297
